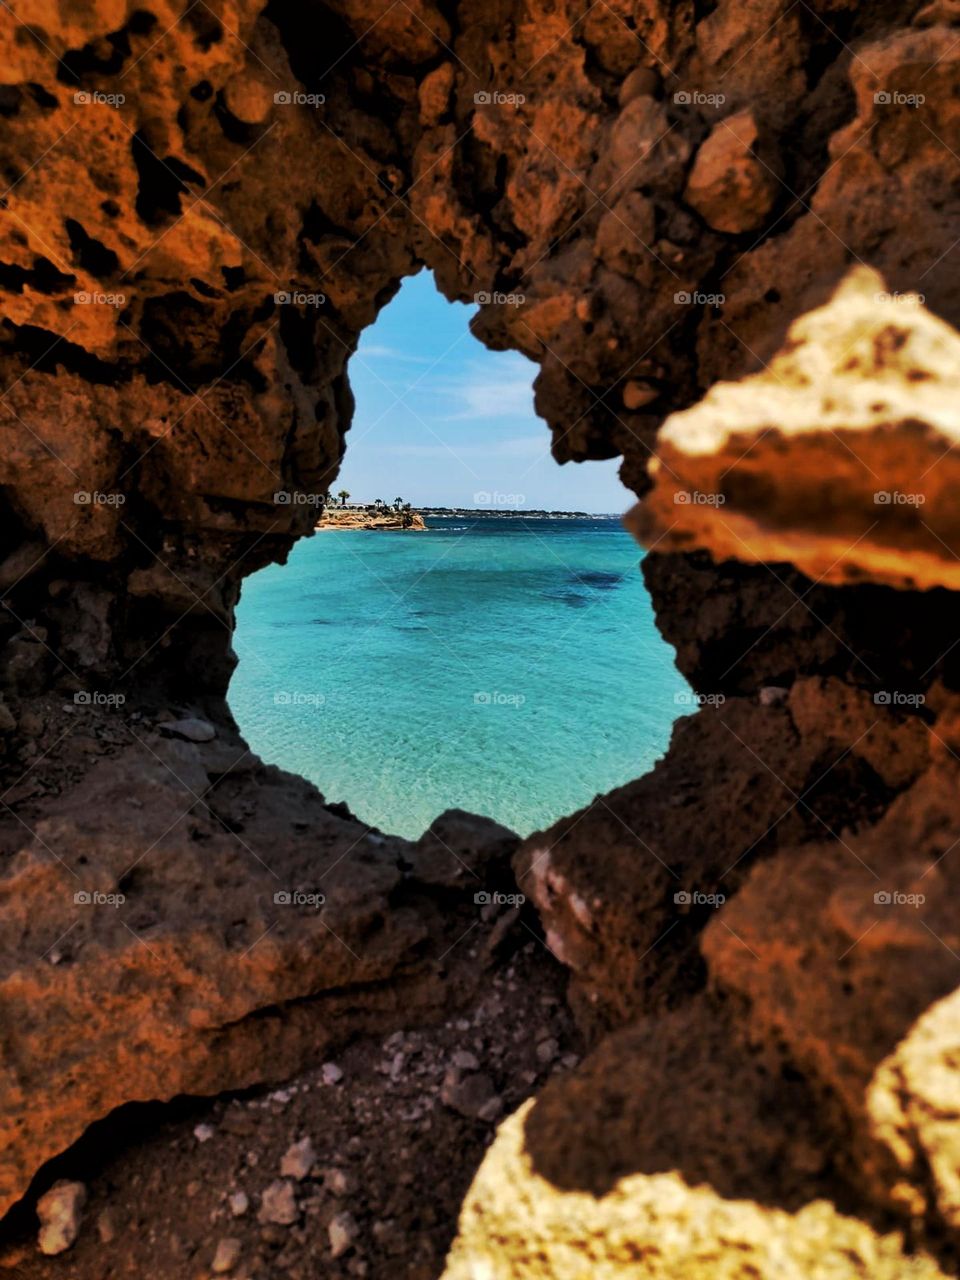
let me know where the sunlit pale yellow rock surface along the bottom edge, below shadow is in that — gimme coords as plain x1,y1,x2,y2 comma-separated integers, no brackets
443,1102,945,1280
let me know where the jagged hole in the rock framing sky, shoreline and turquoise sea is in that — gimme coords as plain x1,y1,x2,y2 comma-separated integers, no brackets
230,271,692,836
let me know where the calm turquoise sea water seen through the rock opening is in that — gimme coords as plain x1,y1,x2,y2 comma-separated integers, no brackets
229,517,689,837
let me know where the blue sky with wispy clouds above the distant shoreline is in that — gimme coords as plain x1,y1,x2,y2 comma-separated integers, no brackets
333,270,634,512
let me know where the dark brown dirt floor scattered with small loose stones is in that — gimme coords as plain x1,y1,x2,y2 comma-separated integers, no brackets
0,923,581,1280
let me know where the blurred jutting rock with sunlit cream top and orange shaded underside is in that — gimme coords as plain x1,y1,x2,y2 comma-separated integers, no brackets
628,268,960,590
